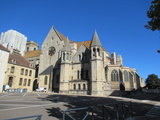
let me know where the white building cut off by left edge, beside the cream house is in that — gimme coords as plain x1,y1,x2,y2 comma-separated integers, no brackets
0,44,10,93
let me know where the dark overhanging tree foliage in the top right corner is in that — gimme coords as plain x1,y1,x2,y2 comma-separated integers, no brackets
145,0,160,31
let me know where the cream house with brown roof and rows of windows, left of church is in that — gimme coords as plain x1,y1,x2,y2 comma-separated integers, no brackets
3,49,35,92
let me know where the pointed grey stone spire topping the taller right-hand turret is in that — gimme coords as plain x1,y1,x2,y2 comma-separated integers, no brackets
91,30,102,46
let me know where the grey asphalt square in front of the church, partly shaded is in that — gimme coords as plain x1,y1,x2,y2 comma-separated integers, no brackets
0,93,159,120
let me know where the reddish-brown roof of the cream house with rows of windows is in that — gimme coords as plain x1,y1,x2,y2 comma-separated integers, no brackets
8,52,30,67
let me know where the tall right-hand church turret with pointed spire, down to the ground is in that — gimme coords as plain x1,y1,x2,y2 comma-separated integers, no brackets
91,31,105,95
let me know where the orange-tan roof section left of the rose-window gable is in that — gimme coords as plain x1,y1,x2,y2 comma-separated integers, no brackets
24,49,41,58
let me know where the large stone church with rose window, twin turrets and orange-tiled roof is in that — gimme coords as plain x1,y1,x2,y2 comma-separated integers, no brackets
24,27,143,96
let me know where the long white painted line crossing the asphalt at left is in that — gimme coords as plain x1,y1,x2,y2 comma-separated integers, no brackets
0,102,65,112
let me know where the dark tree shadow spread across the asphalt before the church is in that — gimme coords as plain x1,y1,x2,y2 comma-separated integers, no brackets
39,94,152,120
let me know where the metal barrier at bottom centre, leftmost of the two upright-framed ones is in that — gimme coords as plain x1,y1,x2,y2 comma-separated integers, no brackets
63,106,94,120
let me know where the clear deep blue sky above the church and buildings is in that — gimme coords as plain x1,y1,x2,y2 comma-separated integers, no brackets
0,0,160,79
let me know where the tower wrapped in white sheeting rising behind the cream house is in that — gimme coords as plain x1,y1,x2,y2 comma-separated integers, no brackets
0,30,27,56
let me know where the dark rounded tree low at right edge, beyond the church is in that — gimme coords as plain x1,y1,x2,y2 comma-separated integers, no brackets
146,74,160,89
